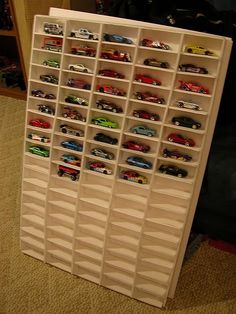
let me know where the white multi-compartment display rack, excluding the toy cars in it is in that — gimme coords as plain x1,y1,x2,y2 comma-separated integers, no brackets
20,8,232,307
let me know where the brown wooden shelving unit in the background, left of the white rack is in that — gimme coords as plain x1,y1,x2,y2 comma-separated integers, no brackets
0,0,27,100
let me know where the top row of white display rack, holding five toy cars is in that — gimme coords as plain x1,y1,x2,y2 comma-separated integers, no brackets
35,16,224,59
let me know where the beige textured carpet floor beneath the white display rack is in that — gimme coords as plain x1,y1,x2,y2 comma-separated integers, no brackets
0,96,236,314
